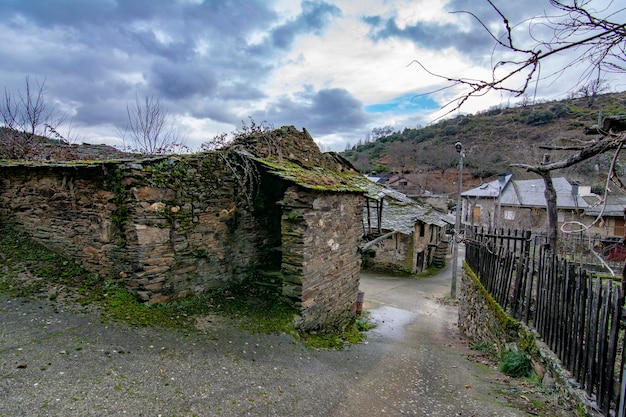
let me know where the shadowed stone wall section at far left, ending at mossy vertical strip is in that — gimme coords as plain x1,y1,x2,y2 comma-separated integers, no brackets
0,164,128,276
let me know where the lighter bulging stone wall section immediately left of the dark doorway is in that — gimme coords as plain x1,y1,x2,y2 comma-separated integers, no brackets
118,153,266,302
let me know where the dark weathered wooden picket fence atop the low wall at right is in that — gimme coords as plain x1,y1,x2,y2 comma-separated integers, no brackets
465,229,626,416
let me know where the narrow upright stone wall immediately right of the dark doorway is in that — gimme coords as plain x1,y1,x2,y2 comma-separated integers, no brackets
280,187,364,330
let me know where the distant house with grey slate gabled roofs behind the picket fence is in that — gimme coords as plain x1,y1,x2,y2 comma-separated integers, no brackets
461,174,592,231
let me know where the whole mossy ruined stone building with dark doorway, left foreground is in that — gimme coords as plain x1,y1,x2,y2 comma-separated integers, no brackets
0,127,364,330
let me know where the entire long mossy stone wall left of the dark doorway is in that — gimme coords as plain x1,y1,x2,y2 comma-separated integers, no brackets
0,154,266,303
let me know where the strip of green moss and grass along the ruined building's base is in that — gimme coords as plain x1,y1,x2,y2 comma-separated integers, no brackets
0,224,370,348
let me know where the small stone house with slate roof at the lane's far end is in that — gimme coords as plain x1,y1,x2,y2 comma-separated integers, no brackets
363,183,454,274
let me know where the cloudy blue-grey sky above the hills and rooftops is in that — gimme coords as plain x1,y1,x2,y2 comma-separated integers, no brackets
0,0,626,150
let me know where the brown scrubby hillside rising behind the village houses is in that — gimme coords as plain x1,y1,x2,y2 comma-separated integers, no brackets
342,92,626,193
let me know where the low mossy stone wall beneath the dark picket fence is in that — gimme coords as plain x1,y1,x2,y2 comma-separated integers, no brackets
459,262,590,413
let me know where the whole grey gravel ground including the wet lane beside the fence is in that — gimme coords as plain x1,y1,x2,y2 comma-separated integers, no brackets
0,264,575,417
